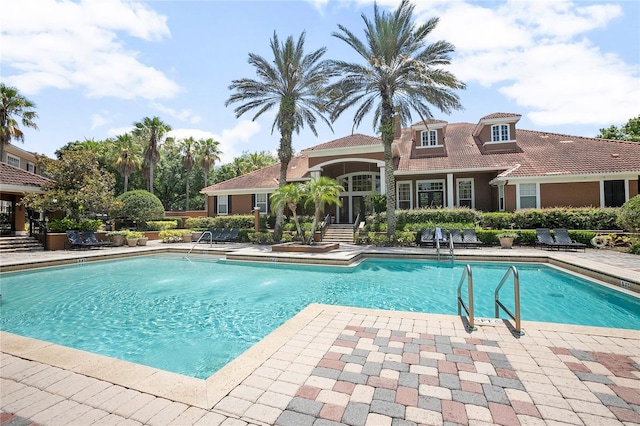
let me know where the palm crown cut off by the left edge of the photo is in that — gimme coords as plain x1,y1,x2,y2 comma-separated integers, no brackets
0,83,38,161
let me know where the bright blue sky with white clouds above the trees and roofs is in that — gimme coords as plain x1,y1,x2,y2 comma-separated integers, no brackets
0,0,640,163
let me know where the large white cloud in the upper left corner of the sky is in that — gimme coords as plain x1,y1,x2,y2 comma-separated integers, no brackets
0,0,180,99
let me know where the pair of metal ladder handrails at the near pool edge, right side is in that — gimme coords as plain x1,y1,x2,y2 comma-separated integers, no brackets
458,264,524,336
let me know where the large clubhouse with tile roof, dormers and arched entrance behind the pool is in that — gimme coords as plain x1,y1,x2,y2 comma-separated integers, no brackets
201,113,640,223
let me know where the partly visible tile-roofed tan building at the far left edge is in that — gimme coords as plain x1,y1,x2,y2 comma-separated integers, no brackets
0,144,49,236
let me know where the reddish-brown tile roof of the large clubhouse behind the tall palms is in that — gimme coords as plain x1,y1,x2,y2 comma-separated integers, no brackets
205,120,640,191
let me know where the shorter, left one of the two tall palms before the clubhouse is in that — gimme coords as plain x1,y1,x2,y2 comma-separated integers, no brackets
225,32,331,239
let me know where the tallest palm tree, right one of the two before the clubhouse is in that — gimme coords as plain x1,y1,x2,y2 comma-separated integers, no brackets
330,0,465,237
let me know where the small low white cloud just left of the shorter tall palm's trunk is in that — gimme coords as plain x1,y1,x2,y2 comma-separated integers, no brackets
167,120,260,164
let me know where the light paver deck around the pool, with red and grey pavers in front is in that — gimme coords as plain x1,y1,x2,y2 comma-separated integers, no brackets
0,244,640,426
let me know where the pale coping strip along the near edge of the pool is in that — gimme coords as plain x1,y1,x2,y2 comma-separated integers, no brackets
0,303,640,409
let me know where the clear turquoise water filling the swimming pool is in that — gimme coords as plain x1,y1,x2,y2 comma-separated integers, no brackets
0,255,640,378
